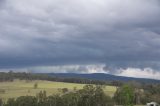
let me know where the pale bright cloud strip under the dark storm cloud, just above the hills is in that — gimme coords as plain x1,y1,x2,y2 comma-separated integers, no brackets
5,64,160,80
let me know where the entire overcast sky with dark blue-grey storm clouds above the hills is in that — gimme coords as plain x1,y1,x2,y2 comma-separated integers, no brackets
0,0,160,79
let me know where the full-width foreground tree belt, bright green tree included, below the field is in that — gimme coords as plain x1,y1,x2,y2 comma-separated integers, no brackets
0,84,160,106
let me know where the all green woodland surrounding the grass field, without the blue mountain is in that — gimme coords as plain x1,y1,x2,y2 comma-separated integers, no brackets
0,72,160,106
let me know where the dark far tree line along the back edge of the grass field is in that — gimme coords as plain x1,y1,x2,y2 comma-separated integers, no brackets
0,71,122,86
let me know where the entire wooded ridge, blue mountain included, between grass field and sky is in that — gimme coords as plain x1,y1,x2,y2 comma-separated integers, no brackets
0,71,160,84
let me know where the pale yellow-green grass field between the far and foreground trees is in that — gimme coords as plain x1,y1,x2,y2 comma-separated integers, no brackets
0,80,116,101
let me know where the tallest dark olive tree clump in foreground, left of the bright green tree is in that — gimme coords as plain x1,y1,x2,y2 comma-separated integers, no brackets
79,85,113,106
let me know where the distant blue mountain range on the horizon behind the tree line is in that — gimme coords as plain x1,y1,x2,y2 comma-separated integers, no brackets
47,73,160,83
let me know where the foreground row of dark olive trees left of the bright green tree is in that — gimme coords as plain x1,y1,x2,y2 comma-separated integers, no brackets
0,85,114,106
